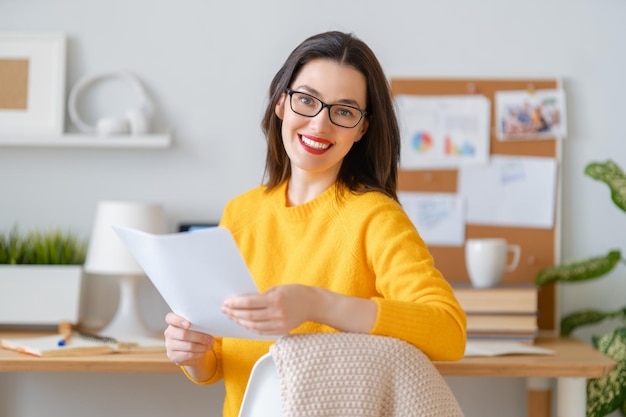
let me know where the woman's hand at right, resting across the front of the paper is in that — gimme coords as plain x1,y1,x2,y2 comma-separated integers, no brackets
222,284,316,335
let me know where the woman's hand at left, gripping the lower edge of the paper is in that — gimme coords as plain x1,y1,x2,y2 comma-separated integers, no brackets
163,313,214,381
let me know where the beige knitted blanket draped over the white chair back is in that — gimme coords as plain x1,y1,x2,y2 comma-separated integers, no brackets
270,333,463,417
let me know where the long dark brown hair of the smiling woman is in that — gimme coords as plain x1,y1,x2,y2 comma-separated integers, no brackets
262,32,400,200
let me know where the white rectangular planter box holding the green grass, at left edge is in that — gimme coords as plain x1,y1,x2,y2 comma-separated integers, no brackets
0,265,82,325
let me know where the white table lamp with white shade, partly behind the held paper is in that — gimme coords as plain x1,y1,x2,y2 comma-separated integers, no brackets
84,201,165,339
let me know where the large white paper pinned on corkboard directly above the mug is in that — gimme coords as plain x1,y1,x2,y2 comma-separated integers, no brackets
458,155,557,229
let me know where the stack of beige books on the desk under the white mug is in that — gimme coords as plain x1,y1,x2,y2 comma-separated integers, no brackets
454,285,539,342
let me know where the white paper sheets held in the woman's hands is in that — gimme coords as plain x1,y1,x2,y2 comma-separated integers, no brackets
114,226,278,340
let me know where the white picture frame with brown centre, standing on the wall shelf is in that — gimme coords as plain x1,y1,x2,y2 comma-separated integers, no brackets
0,33,67,136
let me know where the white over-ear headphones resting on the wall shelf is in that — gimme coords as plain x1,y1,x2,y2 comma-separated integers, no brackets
68,71,154,136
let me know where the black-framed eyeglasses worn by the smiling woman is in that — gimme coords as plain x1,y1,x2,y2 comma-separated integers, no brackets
287,90,367,128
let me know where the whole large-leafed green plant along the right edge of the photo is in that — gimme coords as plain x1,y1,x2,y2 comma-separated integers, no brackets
536,160,626,417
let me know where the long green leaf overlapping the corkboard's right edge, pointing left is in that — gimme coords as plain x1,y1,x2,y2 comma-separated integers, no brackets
535,250,622,286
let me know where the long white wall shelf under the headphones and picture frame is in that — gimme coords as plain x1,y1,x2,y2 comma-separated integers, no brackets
0,133,172,148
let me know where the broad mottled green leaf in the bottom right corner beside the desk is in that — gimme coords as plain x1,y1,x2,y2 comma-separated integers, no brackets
587,328,626,417
